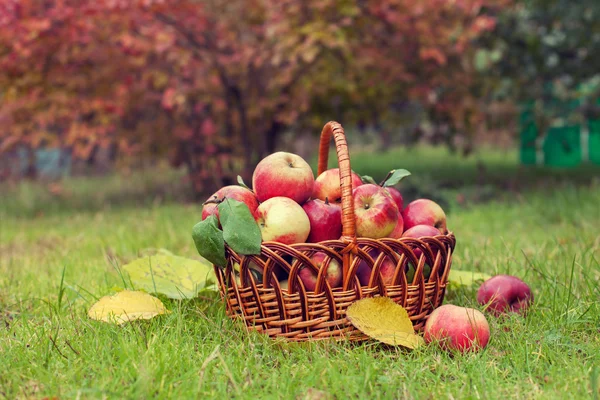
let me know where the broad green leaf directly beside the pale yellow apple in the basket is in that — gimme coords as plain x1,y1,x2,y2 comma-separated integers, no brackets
219,199,262,254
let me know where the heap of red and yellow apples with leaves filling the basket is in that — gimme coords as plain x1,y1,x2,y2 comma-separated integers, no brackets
194,152,448,291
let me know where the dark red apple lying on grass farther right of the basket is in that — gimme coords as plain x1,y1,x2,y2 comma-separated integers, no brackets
477,275,533,316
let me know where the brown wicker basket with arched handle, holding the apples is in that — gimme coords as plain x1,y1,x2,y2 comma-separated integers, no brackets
215,122,456,341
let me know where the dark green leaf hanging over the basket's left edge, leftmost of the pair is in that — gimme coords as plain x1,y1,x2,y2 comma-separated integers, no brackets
192,215,227,267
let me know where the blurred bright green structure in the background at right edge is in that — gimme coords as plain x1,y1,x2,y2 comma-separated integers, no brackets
519,95,600,167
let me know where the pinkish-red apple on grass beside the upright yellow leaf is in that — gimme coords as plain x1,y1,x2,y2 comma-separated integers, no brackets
423,304,490,352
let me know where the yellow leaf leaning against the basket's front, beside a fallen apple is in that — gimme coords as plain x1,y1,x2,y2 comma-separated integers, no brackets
346,297,424,349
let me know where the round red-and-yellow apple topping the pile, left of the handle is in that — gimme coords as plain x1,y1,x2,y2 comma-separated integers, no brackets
252,151,315,204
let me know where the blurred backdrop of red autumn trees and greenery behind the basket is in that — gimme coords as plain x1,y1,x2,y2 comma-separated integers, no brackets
0,0,600,216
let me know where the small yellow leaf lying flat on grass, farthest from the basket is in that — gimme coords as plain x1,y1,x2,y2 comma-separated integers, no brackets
88,290,170,325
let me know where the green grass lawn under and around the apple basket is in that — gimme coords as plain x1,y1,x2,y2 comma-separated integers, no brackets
0,150,600,399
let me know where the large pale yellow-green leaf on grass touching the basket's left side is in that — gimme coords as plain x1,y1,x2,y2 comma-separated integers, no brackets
123,254,216,299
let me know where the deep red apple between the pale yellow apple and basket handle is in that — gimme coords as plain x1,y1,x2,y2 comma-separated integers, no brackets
302,198,342,243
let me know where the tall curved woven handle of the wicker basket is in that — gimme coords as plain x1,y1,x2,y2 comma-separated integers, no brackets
317,121,357,290
